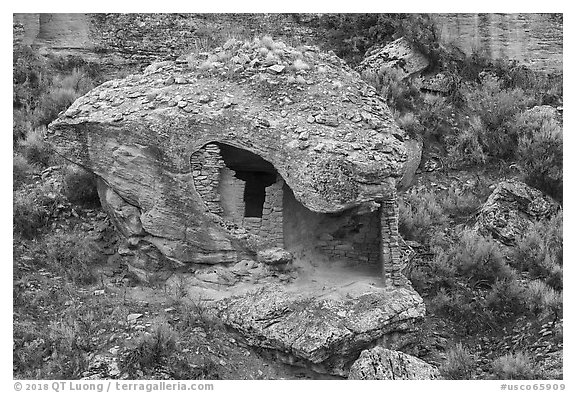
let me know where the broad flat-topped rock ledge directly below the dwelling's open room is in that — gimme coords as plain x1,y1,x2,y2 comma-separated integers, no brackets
218,285,425,376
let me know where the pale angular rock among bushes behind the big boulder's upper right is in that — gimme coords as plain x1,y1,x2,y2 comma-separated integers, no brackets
358,37,429,78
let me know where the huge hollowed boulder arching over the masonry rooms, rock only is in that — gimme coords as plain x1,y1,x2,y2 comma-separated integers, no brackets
47,36,406,265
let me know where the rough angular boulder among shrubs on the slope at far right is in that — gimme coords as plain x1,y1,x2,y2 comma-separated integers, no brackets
474,181,560,246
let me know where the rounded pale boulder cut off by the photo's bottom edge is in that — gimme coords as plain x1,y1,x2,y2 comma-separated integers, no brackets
348,346,439,379
